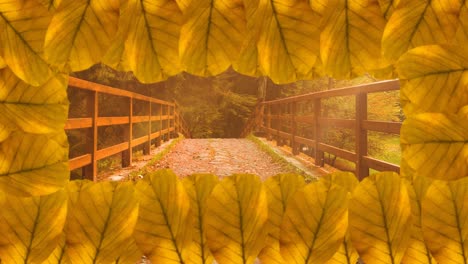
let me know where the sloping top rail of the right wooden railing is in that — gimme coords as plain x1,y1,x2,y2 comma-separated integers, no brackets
264,80,400,104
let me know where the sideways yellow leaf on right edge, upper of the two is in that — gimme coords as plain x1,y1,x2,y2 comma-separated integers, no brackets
397,45,468,115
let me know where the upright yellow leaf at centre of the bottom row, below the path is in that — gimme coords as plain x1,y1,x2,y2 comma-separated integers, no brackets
204,174,268,264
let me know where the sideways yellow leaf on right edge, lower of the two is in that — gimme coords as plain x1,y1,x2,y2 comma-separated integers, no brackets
401,113,468,180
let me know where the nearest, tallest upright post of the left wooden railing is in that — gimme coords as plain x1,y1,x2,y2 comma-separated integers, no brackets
82,91,99,181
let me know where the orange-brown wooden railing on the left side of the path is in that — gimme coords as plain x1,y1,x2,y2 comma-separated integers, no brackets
65,77,190,180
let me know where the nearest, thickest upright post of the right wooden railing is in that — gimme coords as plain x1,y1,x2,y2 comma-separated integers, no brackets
355,93,369,180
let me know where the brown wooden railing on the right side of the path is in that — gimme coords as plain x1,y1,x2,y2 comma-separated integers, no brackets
243,80,401,179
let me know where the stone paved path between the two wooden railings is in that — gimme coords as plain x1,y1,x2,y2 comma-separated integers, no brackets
148,139,288,180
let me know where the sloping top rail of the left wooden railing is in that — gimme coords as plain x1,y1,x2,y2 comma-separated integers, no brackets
68,77,174,105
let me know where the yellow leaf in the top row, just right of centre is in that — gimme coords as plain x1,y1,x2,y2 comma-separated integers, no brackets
255,0,320,83
